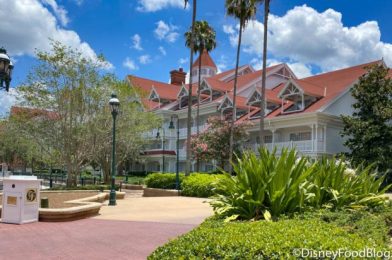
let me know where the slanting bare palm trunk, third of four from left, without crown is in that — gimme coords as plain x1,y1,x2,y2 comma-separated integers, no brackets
229,19,244,174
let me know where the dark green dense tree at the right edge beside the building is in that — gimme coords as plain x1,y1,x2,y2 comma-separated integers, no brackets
342,64,392,177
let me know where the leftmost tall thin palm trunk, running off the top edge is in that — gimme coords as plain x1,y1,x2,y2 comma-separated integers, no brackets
185,0,196,175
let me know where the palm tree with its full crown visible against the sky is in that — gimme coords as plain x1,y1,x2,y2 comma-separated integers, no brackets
185,21,216,172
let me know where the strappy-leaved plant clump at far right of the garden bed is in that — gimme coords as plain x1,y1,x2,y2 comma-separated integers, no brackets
308,159,390,209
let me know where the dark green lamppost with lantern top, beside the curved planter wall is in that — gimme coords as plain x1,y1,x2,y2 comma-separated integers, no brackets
109,93,120,206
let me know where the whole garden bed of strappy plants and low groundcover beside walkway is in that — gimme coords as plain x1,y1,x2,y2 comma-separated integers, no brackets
149,149,392,259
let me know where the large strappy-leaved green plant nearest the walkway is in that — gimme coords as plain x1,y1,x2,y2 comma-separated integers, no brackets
211,149,314,219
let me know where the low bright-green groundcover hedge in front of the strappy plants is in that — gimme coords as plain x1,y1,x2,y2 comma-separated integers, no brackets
148,209,392,260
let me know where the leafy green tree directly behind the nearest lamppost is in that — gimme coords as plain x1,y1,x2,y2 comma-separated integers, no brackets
86,78,160,183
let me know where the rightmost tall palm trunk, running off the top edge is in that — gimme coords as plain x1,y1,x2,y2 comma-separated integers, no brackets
260,0,269,150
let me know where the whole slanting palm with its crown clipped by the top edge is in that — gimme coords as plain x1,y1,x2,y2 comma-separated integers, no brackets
225,0,262,173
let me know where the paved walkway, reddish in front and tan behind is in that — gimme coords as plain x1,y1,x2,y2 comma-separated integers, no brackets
0,193,212,260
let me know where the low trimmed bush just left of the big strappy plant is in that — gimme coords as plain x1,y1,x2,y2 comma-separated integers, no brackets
181,173,226,198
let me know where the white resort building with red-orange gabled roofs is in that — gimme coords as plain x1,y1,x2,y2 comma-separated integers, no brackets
127,52,383,172
